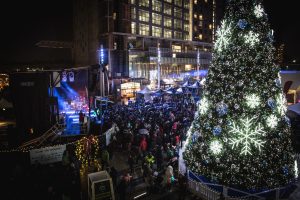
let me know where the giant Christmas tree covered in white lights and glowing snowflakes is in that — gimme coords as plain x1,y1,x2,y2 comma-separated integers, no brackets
183,0,297,190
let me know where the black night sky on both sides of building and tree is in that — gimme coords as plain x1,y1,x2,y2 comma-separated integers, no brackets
0,0,300,67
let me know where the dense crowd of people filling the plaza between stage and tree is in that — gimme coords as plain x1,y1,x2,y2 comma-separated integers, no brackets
102,95,196,199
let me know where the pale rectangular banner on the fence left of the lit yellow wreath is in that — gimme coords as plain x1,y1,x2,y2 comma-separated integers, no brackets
29,144,66,164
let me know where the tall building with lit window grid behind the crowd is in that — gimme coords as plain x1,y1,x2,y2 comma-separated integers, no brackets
73,0,217,85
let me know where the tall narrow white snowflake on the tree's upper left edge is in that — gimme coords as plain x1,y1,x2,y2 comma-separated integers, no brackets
215,20,231,52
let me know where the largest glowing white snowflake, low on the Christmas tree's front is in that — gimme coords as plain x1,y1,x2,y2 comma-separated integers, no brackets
229,117,265,155
